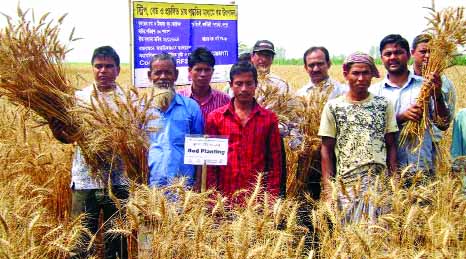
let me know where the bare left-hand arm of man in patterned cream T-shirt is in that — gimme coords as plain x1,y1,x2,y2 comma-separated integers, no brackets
320,137,336,199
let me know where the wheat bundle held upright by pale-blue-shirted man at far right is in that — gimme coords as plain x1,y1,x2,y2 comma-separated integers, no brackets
400,7,466,152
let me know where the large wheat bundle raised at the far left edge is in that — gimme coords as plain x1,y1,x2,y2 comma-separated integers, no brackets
0,7,79,138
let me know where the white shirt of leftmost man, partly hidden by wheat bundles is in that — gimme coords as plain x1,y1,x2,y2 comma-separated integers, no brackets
71,85,128,190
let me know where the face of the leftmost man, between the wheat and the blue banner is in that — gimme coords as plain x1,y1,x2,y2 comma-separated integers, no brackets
92,57,120,90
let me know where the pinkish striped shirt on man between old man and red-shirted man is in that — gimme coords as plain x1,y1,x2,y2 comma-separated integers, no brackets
177,86,230,121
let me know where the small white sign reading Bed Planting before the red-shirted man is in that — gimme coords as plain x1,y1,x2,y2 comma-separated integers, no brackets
184,136,228,165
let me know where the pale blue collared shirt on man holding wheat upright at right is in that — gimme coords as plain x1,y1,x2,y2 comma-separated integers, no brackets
369,72,434,171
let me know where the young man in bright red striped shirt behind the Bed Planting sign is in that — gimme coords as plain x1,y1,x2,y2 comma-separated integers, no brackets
205,62,282,201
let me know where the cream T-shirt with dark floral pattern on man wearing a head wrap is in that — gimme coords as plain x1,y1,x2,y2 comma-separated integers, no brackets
318,94,398,183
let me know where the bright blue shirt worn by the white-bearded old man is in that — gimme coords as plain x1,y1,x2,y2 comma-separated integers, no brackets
147,94,204,187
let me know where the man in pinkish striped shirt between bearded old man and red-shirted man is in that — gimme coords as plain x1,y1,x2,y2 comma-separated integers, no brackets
178,47,230,121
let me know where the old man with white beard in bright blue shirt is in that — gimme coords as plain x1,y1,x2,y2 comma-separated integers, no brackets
147,53,204,187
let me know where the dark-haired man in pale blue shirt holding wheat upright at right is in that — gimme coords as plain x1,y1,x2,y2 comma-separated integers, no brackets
369,34,450,175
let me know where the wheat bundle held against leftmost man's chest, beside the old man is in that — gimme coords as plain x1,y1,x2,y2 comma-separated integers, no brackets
77,87,155,186
